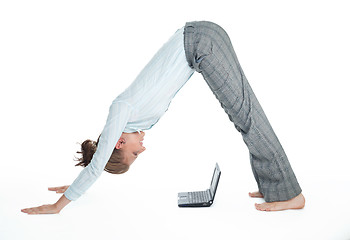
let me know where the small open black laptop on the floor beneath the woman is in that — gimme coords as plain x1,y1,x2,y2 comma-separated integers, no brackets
178,163,221,207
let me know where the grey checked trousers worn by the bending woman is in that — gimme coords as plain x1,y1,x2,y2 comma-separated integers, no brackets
184,21,301,202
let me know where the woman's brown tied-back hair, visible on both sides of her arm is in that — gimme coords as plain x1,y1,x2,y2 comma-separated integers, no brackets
75,137,129,174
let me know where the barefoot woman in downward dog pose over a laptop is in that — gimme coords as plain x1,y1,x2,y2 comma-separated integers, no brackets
22,21,305,214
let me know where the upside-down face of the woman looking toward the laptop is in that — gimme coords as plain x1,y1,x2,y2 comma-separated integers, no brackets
116,131,146,166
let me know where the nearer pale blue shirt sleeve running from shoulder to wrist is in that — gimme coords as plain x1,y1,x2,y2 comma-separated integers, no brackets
64,100,131,201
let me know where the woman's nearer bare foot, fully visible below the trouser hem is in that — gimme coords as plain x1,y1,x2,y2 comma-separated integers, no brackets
255,193,305,211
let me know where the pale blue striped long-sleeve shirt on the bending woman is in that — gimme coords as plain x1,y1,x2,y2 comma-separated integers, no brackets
64,27,195,200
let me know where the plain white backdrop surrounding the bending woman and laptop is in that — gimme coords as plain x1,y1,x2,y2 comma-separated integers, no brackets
0,0,350,240
